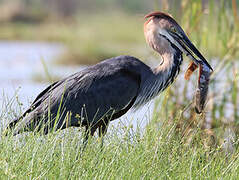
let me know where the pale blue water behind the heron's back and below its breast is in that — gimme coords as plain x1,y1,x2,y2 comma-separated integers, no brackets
0,41,153,133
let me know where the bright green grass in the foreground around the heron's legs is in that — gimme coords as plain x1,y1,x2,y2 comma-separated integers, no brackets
0,105,239,179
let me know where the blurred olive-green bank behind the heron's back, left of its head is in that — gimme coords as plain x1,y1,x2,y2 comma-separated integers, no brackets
0,13,146,65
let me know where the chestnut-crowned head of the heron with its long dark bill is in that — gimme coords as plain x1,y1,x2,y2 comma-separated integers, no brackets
144,11,213,70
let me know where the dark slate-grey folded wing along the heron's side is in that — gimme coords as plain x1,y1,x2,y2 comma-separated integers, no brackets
13,59,140,132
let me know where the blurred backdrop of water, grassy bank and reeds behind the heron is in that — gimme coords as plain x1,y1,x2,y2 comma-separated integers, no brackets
0,0,239,147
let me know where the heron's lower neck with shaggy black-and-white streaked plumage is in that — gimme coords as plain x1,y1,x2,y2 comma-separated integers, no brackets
134,44,183,108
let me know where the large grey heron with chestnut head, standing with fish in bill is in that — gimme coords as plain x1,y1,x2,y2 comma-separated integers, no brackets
5,12,212,140
